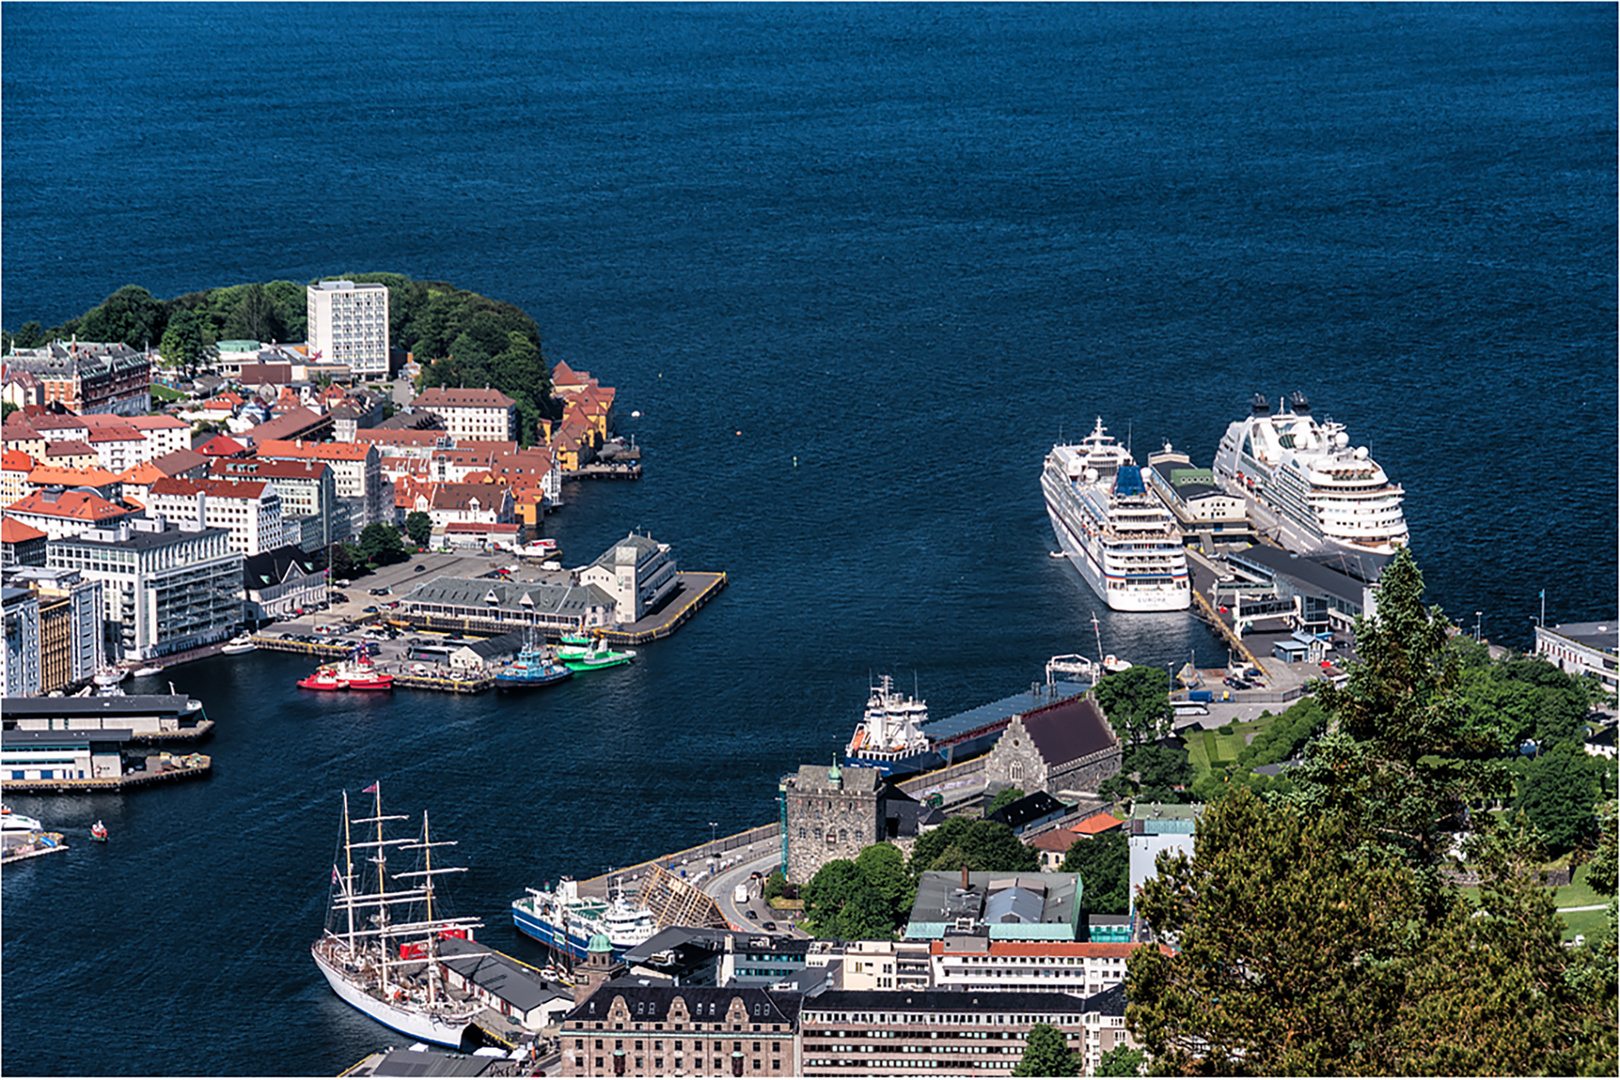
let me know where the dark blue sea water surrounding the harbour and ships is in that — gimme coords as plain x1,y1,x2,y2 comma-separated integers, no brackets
0,3,1617,1075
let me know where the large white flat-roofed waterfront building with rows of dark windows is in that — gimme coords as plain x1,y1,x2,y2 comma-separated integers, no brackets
47,515,243,661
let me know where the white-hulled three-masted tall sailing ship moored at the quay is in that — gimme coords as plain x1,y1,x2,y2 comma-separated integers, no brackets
309,784,483,1048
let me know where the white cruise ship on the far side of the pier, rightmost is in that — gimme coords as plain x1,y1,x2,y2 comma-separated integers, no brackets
1213,390,1408,555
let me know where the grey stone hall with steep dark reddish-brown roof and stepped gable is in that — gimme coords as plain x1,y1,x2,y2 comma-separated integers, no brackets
985,695,1124,795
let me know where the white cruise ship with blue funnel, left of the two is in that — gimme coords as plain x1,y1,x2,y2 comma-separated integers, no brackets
1040,418,1192,612
